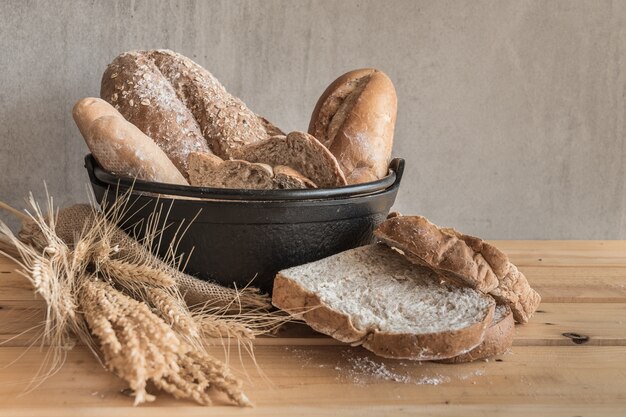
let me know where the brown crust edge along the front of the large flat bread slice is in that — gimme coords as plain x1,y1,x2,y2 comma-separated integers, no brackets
272,272,495,360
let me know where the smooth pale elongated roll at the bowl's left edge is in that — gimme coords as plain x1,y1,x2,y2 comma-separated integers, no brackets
72,97,189,185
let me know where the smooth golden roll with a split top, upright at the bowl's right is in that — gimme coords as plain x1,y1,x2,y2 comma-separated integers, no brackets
309,68,397,184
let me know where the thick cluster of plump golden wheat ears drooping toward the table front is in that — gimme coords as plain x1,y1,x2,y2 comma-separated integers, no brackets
79,278,250,405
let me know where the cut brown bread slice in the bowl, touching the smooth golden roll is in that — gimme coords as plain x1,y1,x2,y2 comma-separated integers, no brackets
234,132,346,187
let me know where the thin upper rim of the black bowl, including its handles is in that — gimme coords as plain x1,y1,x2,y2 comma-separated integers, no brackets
85,153,404,201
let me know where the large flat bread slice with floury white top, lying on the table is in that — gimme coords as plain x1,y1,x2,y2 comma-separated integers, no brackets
272,244,495,360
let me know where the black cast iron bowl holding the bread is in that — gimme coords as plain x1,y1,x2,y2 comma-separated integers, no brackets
85,155,404,291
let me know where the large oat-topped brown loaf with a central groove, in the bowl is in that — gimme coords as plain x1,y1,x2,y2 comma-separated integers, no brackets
100,50,281,166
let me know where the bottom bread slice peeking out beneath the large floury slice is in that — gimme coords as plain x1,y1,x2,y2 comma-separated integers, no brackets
439,304,515,363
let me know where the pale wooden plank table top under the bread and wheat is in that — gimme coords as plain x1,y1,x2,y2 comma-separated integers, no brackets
0,241,626,417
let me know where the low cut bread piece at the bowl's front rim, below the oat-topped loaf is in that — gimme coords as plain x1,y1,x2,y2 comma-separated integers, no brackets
189,152,315,190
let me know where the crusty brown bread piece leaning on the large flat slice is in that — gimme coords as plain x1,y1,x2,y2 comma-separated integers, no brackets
374,216,541,323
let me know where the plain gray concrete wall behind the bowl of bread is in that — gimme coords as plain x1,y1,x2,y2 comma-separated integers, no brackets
0,0,626,239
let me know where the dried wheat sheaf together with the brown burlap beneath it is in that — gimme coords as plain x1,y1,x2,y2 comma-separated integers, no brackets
0,191,287,406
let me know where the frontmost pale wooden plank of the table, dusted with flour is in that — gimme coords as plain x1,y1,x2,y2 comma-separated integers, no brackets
0,346,626,410
